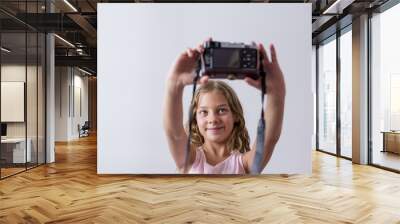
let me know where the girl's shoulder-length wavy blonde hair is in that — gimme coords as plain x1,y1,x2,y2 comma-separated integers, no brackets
186,80,250,153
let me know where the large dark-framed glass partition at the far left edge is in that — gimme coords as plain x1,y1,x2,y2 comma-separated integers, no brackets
0,1,46,179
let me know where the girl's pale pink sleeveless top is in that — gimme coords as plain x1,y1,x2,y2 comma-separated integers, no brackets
188,147,246,174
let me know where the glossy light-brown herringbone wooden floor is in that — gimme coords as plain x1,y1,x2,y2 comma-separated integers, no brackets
0,134,400,224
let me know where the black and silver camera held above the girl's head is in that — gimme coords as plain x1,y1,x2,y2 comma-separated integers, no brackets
201,41,260,80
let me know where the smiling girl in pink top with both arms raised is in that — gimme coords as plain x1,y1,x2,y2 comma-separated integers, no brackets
164,39,286,174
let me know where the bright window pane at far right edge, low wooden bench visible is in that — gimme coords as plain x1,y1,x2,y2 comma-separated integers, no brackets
371,4,400,170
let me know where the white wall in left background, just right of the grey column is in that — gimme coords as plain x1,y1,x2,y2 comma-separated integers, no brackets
55,67,88,141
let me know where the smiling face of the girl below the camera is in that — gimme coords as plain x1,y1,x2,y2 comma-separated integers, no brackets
196,90,234,143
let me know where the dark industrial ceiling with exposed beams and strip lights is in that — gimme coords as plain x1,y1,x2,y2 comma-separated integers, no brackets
0,0,387,73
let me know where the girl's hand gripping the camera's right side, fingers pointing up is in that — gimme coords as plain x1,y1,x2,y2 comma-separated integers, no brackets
245,44,286,98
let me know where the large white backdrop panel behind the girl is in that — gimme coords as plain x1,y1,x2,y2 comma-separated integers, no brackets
97,3,314,174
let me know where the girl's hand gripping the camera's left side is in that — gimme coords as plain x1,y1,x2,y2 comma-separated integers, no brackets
168,40,208,87
